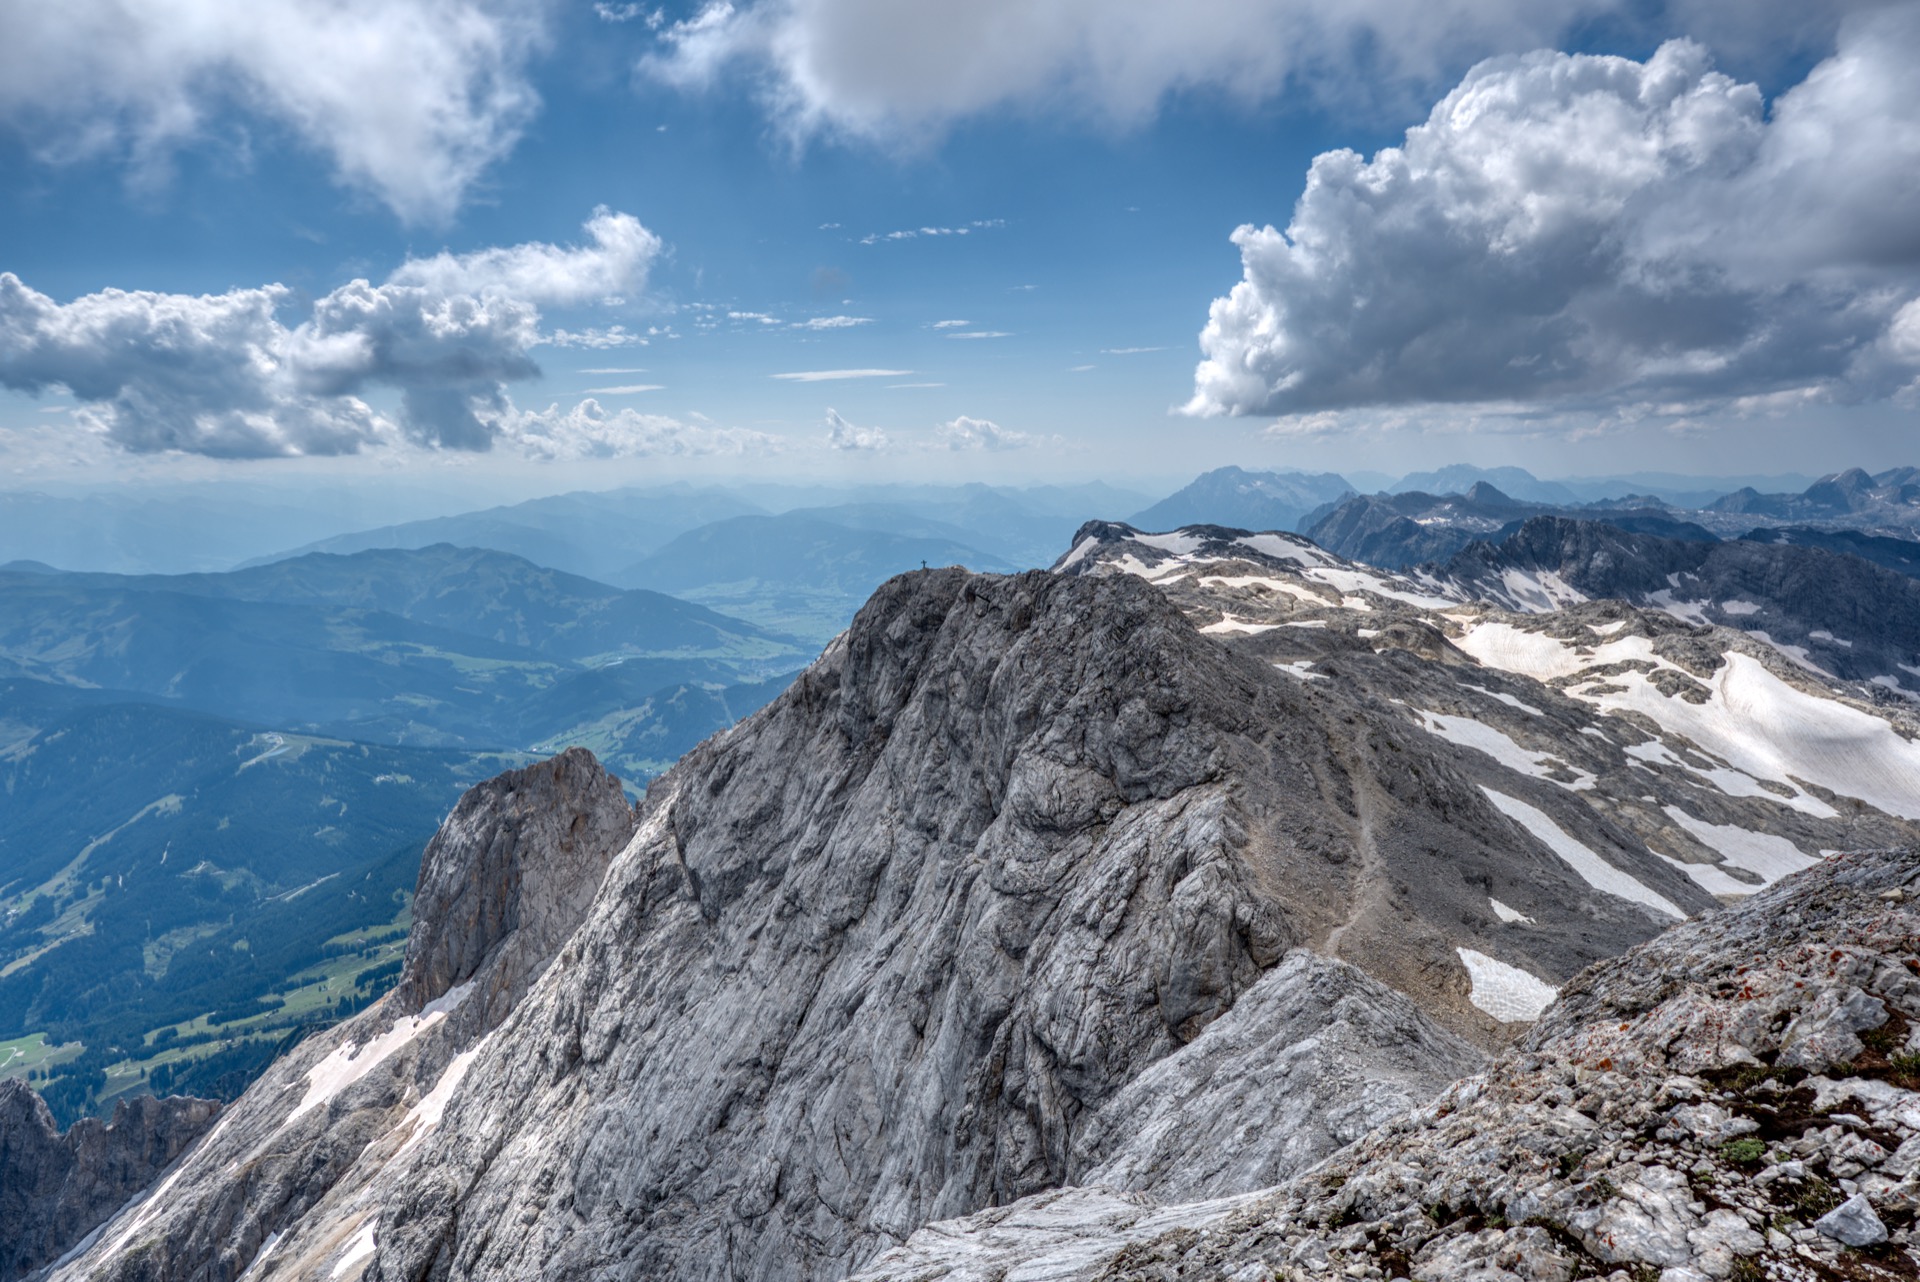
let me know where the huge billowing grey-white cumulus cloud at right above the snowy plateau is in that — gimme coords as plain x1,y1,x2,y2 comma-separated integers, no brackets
1187,4,1920,415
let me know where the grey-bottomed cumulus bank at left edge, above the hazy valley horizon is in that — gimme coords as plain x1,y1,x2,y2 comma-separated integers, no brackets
0,215,651,457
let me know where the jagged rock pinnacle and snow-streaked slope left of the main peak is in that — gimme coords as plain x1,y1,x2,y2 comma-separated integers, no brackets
52,748,634,1282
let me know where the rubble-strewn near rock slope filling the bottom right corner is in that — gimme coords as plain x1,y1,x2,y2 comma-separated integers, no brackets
858,850,1920,1282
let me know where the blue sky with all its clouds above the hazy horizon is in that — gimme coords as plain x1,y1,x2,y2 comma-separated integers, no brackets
0,0,1920,493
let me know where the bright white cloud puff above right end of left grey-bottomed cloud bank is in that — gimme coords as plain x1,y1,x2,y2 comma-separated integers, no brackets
390,205,660,307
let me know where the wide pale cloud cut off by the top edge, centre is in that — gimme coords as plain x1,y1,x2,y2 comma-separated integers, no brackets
643,0,1620,142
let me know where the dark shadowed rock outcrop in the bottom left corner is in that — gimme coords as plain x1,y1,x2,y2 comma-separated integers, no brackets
0,1080,221,1282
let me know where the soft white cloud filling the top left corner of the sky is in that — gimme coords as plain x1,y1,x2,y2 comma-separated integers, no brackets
0,0,541,221
